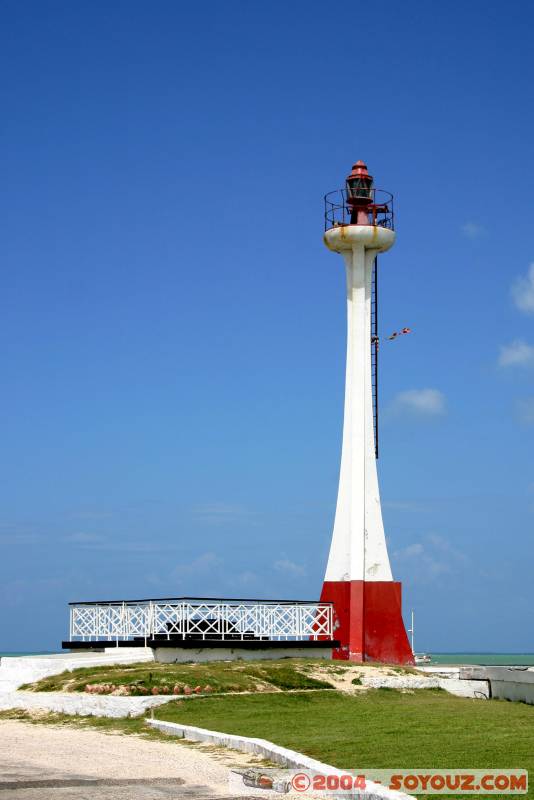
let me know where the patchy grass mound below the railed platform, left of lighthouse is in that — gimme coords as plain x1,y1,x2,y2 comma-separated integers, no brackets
21,659,340,692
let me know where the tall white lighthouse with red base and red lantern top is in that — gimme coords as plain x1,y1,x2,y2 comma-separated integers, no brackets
321,161,413,664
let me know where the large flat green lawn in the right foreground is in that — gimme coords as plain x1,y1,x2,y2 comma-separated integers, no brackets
155,689,534,780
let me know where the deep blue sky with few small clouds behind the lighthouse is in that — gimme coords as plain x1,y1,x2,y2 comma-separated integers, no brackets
0,0,534,651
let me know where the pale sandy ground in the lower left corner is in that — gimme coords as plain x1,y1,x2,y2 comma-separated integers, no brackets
0,720,270,800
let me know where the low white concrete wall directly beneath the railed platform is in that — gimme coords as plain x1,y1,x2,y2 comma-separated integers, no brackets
154,643,332,664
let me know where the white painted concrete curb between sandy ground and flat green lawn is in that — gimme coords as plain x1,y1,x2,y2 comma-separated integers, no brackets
146,719,411,800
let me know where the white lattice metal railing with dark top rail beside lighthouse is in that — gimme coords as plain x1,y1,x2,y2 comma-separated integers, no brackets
70,598,332,642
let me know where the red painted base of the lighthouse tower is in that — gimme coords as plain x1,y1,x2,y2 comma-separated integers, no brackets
321,581,414,664
